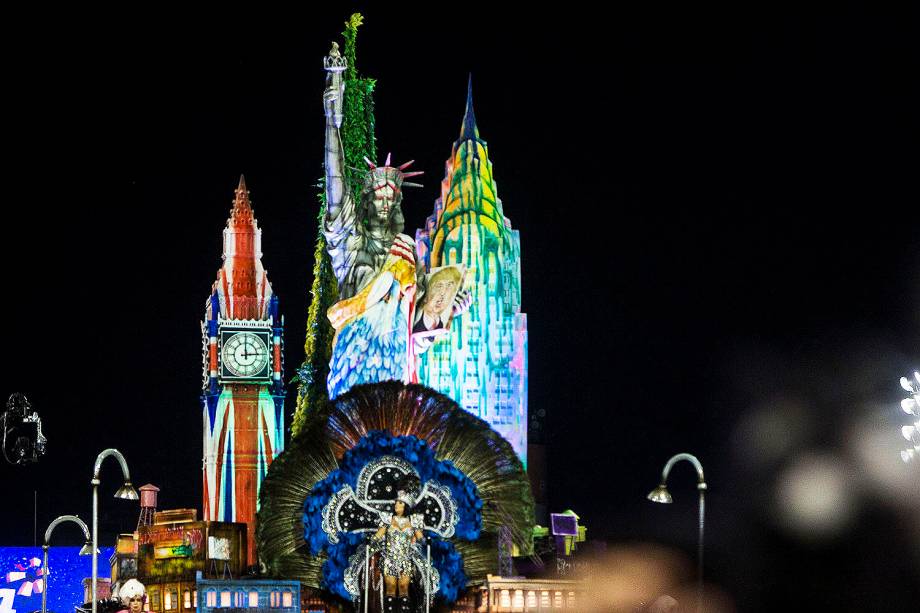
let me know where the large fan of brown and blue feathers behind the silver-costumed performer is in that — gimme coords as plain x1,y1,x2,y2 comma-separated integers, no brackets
256,381,534,596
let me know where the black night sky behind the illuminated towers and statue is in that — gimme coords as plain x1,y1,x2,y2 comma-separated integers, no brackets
0,2,920,611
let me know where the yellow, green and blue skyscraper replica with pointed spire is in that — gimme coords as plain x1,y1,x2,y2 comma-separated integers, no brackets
416,83,527,463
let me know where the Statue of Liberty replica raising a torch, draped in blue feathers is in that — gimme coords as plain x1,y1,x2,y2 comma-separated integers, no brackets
323,43,470,400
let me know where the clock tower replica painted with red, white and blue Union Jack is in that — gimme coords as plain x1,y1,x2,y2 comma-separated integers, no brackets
201,176,285,565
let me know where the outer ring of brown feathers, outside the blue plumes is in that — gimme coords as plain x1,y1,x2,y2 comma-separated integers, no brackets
256,381,534,587
